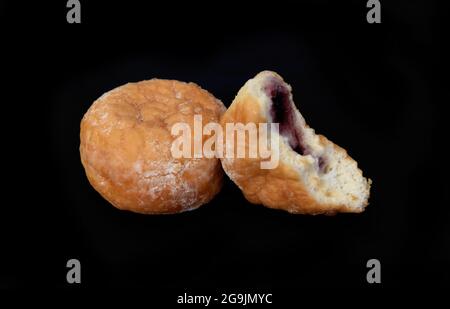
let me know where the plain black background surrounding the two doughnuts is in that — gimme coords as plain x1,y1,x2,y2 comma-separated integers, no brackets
0,0,444,288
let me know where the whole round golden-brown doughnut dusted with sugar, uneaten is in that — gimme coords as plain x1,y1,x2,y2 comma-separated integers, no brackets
80,79,225,214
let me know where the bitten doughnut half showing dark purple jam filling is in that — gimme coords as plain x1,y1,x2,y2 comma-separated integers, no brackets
221,71,371,214
